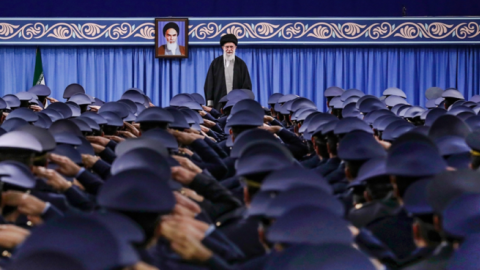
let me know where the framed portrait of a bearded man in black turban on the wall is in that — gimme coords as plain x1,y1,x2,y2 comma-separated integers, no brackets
155,18,188,58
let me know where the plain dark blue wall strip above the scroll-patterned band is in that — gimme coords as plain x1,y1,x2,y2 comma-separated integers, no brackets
0,0,480,17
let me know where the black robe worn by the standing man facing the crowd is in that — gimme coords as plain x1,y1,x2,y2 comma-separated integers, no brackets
204,55,252,110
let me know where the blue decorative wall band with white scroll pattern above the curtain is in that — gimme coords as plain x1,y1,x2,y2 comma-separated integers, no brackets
0,17,480,45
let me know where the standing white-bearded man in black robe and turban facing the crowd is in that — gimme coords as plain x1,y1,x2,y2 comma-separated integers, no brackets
204,34,252,110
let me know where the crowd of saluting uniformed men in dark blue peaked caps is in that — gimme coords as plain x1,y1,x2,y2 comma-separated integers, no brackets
0,84,480,270
